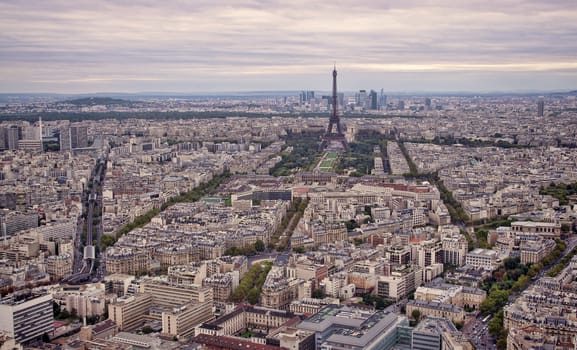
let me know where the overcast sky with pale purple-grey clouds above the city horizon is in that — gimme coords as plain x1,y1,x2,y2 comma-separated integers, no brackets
0,0,577,93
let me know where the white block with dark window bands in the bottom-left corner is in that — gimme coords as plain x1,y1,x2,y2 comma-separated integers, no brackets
0,290,54,343
